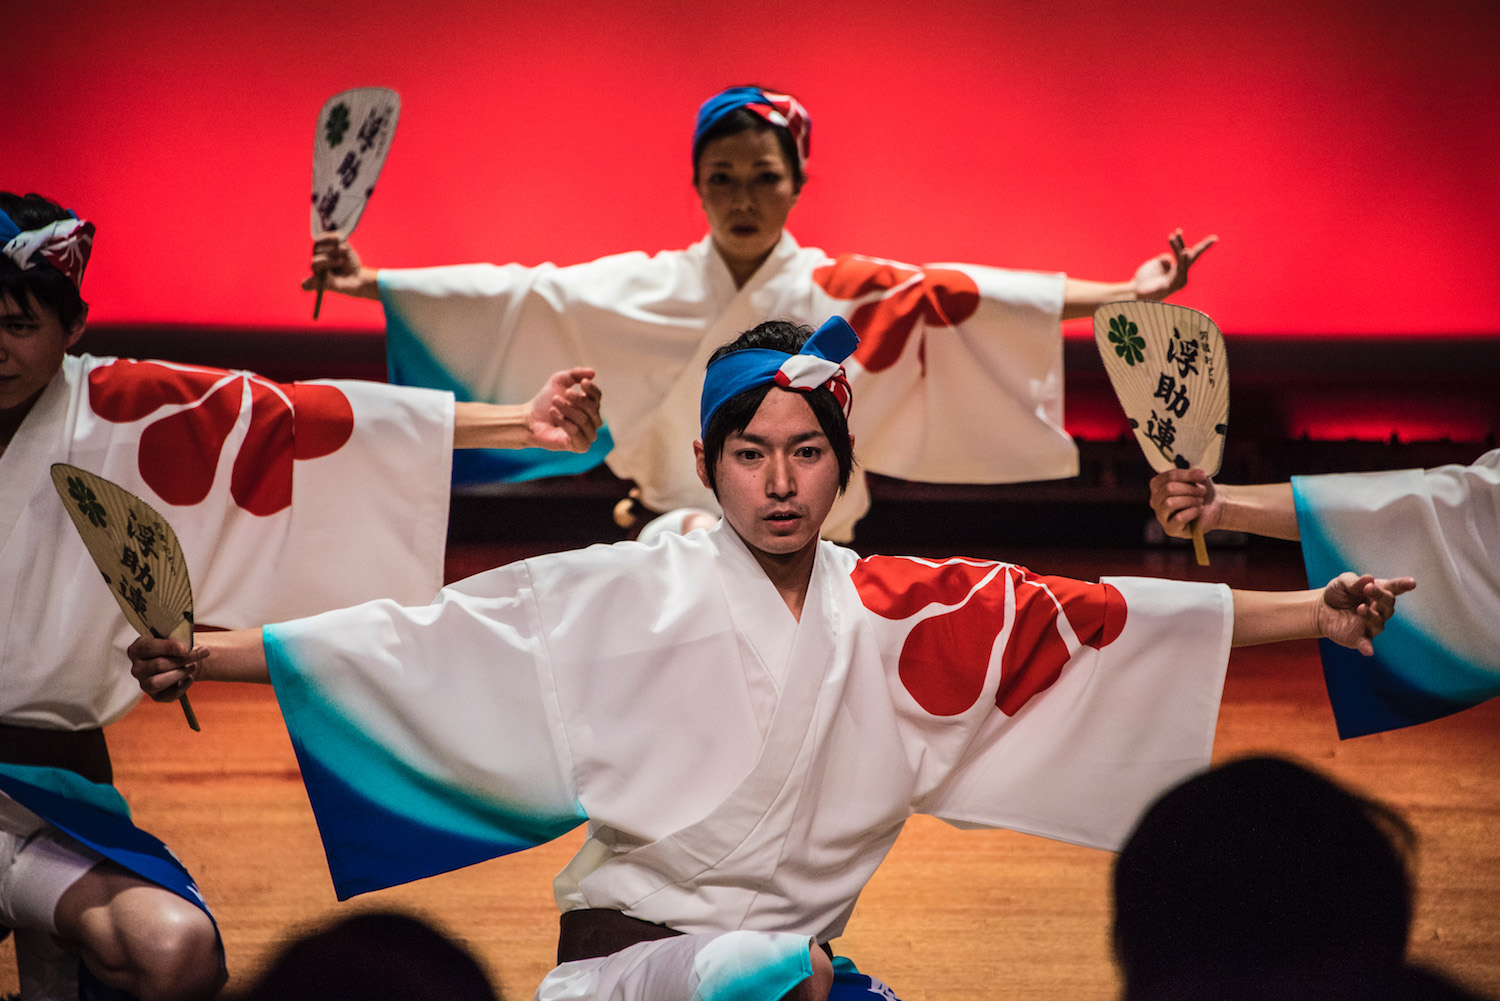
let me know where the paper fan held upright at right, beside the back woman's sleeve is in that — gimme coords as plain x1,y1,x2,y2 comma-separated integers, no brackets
1094,302,1229,566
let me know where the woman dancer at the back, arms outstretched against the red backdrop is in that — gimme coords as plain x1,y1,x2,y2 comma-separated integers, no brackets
306,87,1214,540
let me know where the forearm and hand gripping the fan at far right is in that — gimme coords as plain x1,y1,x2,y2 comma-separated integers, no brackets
1151,470,1302,540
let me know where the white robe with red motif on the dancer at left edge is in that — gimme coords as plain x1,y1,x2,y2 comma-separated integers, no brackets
0,356,453,978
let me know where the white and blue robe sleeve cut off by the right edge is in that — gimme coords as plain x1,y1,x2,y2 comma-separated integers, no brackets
1292,449,1500,737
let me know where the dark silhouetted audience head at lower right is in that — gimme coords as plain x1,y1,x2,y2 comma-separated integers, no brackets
1115,756,1415,999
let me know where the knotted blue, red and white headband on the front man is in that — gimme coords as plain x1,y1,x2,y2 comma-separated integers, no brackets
698,317,860,438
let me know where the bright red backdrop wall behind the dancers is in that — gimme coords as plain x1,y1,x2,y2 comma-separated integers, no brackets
0,0,1500,335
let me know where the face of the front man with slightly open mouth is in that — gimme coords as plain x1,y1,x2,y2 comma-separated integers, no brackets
695,387,839,558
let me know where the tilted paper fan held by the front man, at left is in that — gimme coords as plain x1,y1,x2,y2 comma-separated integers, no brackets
53,462,198,729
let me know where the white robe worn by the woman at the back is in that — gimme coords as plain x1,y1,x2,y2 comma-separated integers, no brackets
380,233,1079,539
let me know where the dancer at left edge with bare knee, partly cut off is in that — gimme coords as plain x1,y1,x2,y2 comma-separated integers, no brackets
0,192,599,1001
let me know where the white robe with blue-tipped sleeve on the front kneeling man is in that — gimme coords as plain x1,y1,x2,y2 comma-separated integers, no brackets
263,524,1233,996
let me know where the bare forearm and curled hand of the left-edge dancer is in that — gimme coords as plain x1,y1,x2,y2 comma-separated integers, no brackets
453,368,603,452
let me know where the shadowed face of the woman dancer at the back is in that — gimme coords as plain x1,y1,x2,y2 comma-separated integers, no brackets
698,128,797,285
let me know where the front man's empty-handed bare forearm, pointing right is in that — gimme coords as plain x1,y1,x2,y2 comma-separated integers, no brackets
1232,573,1416,657
